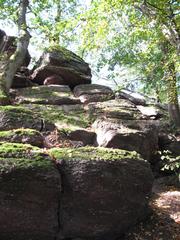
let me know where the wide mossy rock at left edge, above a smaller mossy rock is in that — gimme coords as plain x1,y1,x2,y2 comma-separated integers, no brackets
0,106,54,131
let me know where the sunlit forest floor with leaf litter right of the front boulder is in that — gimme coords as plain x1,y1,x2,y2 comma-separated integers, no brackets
122,176,180,240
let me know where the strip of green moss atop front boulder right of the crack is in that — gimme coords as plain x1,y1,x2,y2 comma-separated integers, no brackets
49,147,141,161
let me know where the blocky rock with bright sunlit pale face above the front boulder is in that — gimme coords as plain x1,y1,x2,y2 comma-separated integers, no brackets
93,118,158,161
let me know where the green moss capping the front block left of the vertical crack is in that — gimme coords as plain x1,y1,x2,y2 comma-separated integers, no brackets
0,143,53,173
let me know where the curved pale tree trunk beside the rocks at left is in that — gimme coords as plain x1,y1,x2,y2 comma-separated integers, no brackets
0,0,30,104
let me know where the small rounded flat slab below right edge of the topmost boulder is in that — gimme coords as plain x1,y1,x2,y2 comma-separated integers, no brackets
73,84,115,103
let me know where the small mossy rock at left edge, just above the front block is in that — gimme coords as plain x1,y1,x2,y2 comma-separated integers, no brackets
0,128,44,147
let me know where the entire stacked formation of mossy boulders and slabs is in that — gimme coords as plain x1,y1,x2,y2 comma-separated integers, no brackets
0,38,179,240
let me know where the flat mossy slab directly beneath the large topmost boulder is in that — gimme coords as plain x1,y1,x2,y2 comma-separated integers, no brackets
13,85,80,105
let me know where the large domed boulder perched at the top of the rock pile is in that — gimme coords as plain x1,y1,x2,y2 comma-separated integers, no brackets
31,47,91,88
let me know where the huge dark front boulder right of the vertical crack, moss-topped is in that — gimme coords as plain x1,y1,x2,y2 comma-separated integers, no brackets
51,148,152,240
